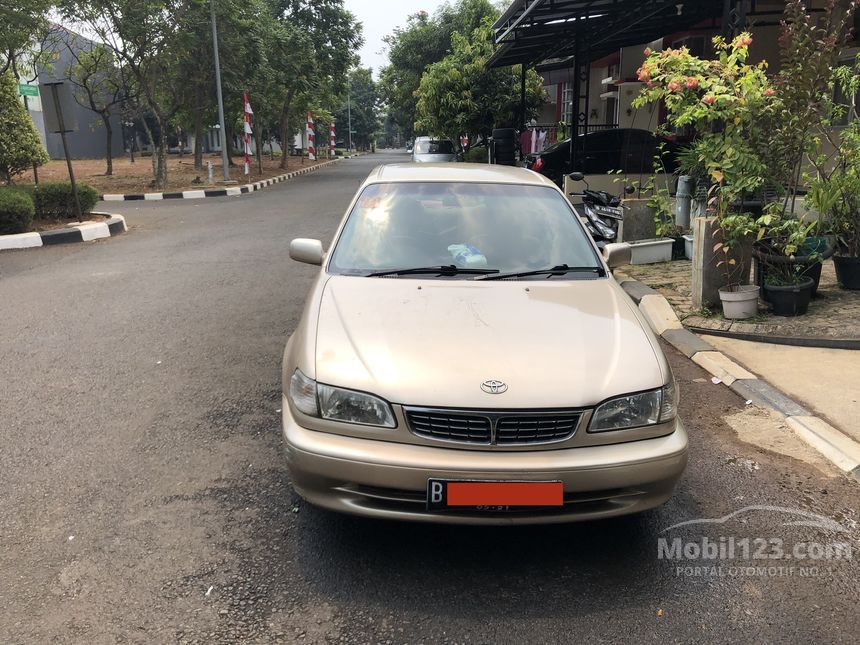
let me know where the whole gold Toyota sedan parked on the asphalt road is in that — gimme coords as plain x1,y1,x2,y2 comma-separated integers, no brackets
283,164,687,523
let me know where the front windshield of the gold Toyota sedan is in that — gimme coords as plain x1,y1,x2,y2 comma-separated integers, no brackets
328,182,602,279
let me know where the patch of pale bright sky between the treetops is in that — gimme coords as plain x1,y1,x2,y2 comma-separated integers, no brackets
344,0,450,77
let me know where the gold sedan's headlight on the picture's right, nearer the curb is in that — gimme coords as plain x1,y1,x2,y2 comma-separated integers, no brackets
588,379,678,432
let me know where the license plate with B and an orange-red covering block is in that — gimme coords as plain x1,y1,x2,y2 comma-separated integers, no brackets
427,479,564,511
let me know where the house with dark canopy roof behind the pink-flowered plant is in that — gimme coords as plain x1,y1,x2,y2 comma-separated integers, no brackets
488,0,860,158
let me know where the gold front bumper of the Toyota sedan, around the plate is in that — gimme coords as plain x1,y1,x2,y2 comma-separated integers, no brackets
283,400,687,524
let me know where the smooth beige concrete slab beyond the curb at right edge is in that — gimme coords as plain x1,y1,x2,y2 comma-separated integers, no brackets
702,335,860,442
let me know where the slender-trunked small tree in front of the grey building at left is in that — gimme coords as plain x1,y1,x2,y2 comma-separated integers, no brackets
54,27,127,176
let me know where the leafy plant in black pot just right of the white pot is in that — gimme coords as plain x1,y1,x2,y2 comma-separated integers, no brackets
753,204,820,316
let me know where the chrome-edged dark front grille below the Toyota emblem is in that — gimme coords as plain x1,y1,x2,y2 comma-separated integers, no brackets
404,407,580,445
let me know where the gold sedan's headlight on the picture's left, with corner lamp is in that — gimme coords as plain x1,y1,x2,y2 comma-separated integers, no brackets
290,370,397,428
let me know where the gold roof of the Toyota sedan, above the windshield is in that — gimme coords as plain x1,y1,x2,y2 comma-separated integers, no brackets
363,163,555,188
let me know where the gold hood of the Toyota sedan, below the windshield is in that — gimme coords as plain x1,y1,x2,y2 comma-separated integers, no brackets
311,276,667,408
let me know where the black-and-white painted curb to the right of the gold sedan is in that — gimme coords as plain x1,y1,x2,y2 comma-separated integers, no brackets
615,272,860,481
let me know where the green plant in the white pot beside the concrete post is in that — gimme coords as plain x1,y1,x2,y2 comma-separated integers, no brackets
714,213,759,320
